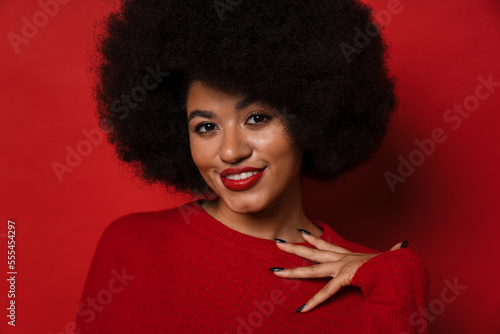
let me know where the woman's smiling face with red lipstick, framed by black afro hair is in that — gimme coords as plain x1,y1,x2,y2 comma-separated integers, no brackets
186,81,303,213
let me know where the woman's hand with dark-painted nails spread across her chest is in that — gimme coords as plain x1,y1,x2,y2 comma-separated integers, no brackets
269,231,408,313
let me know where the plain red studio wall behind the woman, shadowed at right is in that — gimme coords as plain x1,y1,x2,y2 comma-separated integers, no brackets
0,0,500,334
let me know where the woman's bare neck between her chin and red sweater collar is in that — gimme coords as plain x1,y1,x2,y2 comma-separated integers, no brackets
202,177,322,243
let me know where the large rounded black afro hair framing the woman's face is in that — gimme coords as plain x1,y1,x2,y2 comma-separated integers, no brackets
93,0,398,195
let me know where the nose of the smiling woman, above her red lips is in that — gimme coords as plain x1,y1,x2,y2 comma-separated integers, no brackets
220,126,253,164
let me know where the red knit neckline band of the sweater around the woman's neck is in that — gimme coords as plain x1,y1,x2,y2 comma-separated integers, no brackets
179,199,343,256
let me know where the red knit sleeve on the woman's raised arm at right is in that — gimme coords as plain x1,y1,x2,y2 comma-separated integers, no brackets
352,248,429,334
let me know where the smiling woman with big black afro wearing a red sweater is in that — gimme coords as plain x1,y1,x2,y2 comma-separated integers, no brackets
77,0,427,333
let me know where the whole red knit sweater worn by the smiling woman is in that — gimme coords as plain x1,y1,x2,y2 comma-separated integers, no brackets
76,200,428,334
